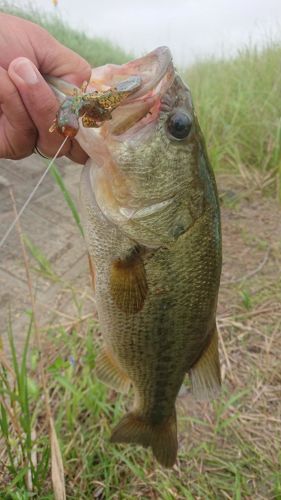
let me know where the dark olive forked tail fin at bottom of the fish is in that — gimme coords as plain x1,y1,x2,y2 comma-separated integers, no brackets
111,410,178,467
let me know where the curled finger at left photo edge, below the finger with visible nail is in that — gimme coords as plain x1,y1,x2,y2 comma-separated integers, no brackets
0,67,37,159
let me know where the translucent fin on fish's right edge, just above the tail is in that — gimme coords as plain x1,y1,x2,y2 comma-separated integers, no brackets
189,327,221,399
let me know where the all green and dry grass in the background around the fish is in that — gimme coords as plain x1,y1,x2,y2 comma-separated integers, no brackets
0,2,281,500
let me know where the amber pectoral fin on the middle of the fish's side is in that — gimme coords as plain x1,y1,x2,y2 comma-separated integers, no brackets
110,249,148,314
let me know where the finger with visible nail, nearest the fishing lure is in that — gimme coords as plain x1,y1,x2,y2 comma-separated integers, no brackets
8,57,71,160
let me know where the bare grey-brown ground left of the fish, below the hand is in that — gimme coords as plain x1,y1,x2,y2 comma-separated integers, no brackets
0,155,89,352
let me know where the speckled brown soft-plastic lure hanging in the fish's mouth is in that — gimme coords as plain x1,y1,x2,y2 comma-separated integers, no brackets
49,76,141,137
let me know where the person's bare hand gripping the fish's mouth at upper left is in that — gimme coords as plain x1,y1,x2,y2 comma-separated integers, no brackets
0,14,91,163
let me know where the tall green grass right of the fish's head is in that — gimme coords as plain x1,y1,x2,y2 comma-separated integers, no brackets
184,43,281,187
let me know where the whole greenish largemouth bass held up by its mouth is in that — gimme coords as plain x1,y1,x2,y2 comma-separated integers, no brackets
49,47,222,468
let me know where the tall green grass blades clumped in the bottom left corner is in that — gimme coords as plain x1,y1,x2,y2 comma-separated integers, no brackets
0,319,49,499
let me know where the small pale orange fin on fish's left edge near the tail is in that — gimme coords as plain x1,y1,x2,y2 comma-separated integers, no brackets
96,348,131,393
